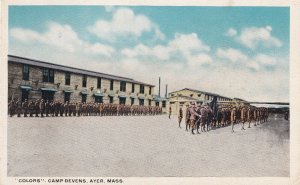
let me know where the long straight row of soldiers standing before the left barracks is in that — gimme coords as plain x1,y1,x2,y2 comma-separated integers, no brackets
8,99,162,117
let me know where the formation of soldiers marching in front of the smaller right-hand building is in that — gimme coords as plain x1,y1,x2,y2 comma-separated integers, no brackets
178,103,269,134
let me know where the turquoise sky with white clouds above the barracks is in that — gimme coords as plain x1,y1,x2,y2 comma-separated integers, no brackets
9,6,290,101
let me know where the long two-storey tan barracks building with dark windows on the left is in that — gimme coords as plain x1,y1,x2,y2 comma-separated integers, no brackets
8,55,166,108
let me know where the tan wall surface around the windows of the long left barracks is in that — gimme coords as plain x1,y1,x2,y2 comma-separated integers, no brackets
8,62,161,106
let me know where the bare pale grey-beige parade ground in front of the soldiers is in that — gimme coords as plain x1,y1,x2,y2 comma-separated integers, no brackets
7,115,290,177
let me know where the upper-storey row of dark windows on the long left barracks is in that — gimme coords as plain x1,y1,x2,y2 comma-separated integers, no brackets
23,65,152,95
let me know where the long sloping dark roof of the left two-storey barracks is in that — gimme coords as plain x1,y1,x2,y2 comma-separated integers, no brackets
8,55,154,87
